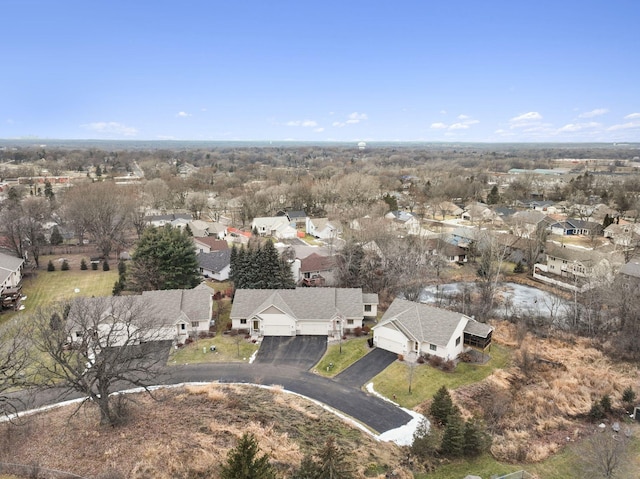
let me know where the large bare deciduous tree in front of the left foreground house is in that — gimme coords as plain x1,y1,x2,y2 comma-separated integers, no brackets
29,296,173,425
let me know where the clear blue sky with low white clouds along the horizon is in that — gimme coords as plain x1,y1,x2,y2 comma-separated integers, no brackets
0,0,640,142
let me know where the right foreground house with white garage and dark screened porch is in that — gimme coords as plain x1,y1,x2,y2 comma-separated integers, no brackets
373,298,493,360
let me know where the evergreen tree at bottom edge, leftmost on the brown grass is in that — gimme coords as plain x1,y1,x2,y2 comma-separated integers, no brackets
220,432,276,479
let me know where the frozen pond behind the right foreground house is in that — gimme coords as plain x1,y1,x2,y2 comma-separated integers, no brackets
419,282,573,318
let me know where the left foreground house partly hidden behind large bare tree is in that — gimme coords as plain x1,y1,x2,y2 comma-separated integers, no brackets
67,284,214,347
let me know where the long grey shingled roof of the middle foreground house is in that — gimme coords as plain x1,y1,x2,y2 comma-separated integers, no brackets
231,288,364,320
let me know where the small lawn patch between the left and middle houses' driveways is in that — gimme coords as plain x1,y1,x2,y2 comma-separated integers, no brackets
169,334,259,364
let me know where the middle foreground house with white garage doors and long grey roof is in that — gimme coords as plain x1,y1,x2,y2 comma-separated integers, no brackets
230,288,378,337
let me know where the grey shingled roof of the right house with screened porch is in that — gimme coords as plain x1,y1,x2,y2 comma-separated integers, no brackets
374,298,493,346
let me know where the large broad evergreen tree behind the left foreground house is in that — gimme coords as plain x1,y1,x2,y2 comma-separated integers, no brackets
127,225,200,291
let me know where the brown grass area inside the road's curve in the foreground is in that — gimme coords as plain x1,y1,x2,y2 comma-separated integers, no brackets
0,384,412,479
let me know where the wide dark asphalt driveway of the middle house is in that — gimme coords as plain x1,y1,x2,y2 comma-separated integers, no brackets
254,336,327,370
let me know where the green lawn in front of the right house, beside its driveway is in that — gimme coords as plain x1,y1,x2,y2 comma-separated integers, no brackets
372,343,511,408
